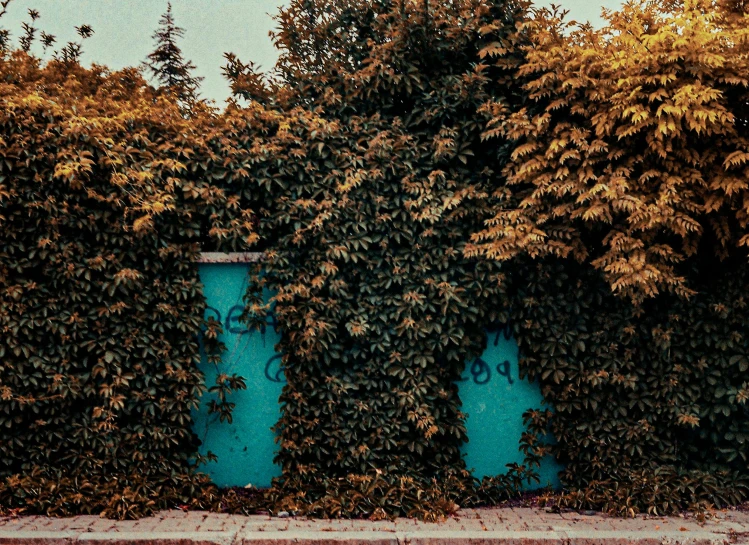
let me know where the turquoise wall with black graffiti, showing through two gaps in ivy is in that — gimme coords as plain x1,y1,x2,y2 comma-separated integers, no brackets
193,264,559,487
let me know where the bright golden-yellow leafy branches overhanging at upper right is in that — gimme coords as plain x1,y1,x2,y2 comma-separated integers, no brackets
466,0,749,301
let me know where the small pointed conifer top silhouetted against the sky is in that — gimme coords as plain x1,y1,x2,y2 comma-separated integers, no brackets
145,2,203,112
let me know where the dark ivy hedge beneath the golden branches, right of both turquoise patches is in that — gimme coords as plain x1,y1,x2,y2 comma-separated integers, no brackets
506,259,749,515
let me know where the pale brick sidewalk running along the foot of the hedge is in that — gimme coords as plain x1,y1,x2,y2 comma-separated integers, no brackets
0,508,749,545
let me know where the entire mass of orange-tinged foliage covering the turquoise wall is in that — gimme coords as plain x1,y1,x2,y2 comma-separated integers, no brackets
0,0,749,518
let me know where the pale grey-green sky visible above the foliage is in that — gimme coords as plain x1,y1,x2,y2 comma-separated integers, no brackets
0,0,622,105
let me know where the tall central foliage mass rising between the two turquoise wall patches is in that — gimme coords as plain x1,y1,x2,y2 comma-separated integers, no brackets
226,0,536,516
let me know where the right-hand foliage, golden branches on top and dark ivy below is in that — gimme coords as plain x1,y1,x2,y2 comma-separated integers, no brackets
467,0,749,513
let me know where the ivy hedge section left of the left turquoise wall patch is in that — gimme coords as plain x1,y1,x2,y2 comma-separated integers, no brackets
0,52,250,517
